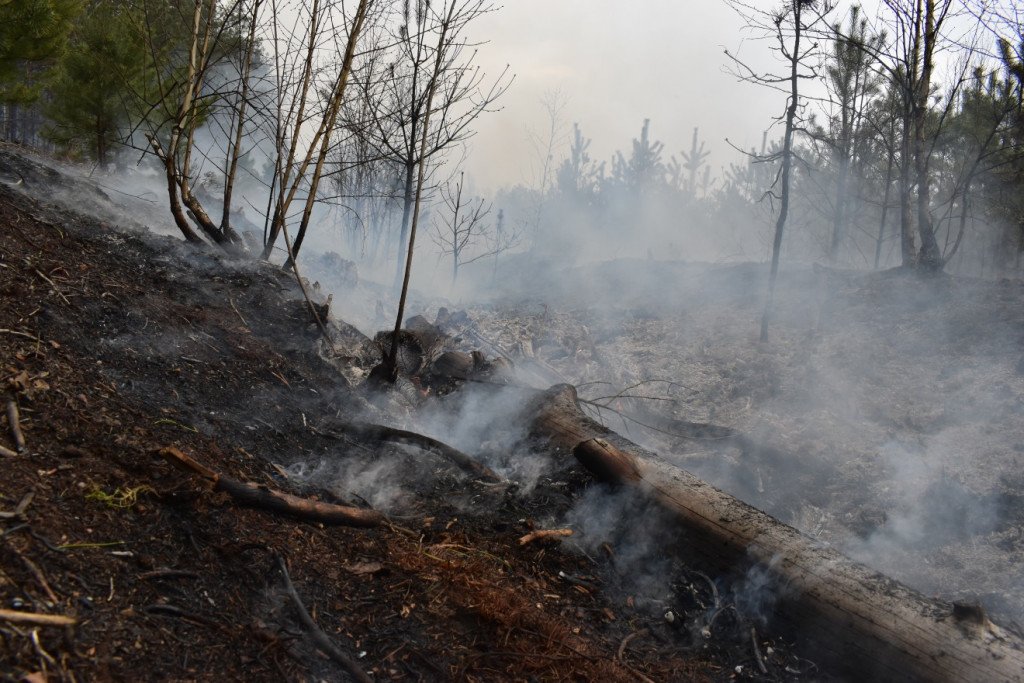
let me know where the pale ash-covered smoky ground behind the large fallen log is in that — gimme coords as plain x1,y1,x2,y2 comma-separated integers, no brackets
438,253,1024,622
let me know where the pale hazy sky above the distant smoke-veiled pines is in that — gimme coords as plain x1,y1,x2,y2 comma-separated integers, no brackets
469,0,785,191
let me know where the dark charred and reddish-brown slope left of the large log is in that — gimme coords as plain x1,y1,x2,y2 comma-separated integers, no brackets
0,150,822,681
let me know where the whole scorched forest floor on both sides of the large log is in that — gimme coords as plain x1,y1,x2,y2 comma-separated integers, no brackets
0,141,1024,680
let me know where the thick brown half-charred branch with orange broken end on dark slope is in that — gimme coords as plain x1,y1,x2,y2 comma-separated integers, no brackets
160,446,384,526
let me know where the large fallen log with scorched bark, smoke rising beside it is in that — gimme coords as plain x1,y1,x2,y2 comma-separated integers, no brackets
529,385,1024,681
